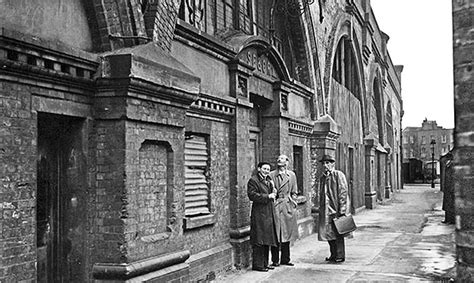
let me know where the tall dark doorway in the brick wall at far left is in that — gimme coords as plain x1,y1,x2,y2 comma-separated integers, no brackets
36,113,86,282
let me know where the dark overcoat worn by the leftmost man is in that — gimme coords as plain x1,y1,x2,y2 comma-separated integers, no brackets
247,174,277,246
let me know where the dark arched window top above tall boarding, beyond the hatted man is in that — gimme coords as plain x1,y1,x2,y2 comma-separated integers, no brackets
332,36,360,98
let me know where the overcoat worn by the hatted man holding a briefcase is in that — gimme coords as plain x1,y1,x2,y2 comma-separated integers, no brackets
318,170,350,241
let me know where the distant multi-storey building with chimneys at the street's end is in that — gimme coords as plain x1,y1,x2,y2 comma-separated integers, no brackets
402,118,454,163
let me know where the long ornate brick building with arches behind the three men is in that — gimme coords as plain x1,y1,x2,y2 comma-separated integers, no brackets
0,0,403,282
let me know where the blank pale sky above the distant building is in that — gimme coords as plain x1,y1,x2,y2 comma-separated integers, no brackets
370,0,454,128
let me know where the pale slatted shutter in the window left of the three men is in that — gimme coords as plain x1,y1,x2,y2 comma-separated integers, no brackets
184,135,209,216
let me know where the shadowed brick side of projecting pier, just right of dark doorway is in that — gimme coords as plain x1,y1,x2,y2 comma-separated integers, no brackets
90,120,127,263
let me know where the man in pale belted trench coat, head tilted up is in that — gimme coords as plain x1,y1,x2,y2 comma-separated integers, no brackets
270,155,298,266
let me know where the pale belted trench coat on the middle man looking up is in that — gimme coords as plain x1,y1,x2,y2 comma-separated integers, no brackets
270,170,298,243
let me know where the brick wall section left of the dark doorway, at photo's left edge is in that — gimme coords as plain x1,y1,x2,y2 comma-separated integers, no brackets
0,80,36,282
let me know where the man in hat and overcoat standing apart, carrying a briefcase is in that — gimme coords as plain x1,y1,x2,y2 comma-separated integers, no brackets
318,155,350,263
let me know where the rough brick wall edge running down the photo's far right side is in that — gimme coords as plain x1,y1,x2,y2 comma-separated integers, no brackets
452,0,474,282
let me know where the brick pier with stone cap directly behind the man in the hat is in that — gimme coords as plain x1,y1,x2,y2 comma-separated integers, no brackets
311,114,341,219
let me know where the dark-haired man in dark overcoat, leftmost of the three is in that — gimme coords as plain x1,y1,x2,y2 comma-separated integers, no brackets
247,162,277,272
